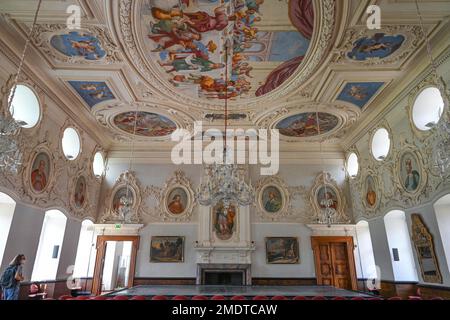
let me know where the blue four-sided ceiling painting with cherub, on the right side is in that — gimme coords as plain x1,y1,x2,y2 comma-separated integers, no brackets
337,82,384,109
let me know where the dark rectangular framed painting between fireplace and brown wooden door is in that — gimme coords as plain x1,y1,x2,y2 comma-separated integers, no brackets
265,237,300,264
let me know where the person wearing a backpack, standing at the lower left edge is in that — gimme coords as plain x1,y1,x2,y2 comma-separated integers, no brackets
0,254,26,300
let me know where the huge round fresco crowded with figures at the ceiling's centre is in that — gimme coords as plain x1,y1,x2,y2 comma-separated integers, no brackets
141,0,314,99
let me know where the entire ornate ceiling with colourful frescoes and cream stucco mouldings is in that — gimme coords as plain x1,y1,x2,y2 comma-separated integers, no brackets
0,0,450,156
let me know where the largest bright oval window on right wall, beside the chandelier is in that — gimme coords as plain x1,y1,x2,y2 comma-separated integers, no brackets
412,87,444,131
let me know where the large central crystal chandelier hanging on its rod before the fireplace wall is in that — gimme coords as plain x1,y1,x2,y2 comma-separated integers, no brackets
196,41,254,210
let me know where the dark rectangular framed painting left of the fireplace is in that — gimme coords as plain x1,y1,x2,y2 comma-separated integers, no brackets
150,236,184,263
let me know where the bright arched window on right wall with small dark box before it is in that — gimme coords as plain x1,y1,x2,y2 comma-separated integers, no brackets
384,210,418,281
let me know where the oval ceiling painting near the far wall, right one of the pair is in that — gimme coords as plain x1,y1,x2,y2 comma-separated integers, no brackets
276,112,339,138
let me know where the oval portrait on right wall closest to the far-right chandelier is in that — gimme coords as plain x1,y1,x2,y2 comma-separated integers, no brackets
398,151,422,193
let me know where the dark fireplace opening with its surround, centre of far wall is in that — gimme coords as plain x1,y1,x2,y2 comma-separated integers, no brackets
196,263,251,286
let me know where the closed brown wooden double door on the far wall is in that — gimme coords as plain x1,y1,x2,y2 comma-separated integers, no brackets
311,237,357,290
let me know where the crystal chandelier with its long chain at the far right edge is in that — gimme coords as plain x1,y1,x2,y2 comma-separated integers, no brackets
415,0,450,178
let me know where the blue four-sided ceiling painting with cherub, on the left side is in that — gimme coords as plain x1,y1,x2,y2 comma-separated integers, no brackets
69,81,115,108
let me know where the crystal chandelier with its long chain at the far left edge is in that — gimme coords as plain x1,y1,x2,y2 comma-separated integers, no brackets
0,0,42,174
